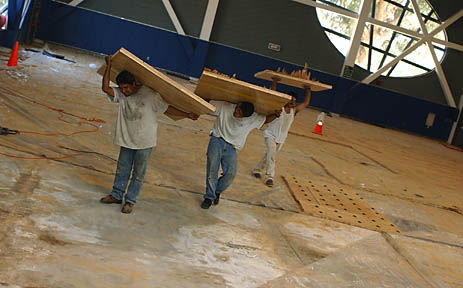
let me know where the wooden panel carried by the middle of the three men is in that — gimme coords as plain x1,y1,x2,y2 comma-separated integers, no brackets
195,71,291,115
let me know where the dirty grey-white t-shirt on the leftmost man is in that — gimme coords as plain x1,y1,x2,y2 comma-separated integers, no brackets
108,86,169,149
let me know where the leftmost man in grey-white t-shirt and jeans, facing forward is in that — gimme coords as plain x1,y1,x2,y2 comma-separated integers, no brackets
100,56,198,213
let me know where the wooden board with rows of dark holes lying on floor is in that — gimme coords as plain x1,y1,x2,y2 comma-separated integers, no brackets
282,176,400,233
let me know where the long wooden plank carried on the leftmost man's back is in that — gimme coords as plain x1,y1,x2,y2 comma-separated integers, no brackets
98,48,215,119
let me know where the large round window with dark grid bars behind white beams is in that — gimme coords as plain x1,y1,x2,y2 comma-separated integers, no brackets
316,0,447,77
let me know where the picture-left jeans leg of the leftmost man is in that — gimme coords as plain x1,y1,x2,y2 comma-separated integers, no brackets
111,147,135,200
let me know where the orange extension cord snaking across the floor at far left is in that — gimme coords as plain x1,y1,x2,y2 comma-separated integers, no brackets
0,87,106,160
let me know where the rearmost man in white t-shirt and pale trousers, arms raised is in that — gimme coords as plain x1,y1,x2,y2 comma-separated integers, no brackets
252,87,310,187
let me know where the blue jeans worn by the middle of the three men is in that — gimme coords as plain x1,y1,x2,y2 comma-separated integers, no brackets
204,136,237,201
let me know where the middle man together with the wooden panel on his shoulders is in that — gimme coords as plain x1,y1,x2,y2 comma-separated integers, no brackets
195,70,291,209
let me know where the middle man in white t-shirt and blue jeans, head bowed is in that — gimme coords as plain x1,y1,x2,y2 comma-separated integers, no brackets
201,100,279,209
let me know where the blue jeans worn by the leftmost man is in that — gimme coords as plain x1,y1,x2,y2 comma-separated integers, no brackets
111,147,153,204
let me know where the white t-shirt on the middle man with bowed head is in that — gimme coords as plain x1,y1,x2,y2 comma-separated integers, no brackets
210,100,265,151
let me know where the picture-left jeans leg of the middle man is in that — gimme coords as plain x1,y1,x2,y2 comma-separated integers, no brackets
204,136,226,201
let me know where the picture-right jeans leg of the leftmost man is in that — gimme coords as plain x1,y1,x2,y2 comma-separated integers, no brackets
125,148,153,204
